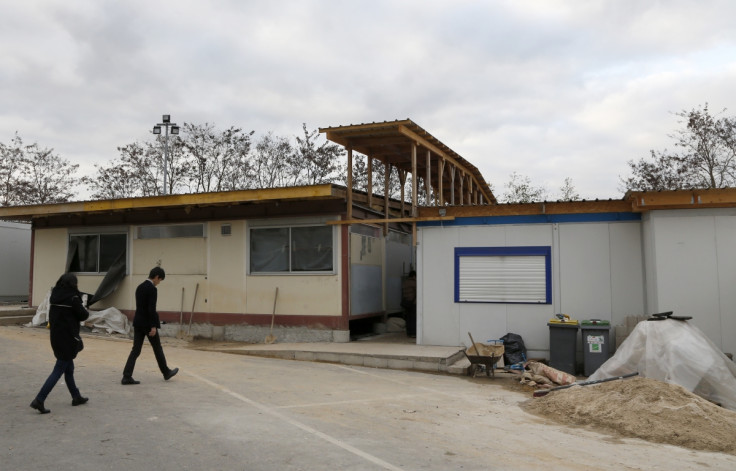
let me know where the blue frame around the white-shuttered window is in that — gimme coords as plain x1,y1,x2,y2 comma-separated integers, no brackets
454,246,552,304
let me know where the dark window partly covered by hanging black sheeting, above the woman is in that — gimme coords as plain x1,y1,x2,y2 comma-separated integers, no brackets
66,233,128,273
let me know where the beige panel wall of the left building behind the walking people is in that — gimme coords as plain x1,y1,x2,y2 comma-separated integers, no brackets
32,221,342,321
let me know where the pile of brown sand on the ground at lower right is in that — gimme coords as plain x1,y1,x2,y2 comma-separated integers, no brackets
523,377,736,455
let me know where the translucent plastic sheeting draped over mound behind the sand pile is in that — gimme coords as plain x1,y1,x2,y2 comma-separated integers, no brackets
588,319,736,410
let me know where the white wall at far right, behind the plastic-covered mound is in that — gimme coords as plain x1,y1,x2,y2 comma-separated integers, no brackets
643,208,736,352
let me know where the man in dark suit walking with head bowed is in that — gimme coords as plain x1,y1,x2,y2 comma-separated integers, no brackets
120,267,179,384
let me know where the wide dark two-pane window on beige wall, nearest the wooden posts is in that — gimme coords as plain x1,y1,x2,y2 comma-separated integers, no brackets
250,226,334,273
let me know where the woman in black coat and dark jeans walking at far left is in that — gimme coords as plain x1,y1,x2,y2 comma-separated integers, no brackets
31,273,89,414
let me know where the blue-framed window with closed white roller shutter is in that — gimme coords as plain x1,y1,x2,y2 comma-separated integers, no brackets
455,247,552,304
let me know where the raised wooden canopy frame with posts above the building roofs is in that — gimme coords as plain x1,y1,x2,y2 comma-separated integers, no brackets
319,119,497,220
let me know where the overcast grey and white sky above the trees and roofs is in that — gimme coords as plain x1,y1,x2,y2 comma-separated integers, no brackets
0,0,736,199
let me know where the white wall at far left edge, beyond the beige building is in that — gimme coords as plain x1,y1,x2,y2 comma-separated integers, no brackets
0,222,31,301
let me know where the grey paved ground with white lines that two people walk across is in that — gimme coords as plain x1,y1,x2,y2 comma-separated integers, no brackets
0,327,736,471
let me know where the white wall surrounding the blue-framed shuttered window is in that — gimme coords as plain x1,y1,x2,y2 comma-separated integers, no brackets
417,221,645,357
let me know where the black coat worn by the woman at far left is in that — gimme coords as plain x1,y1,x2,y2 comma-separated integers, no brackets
49,288,89,361
